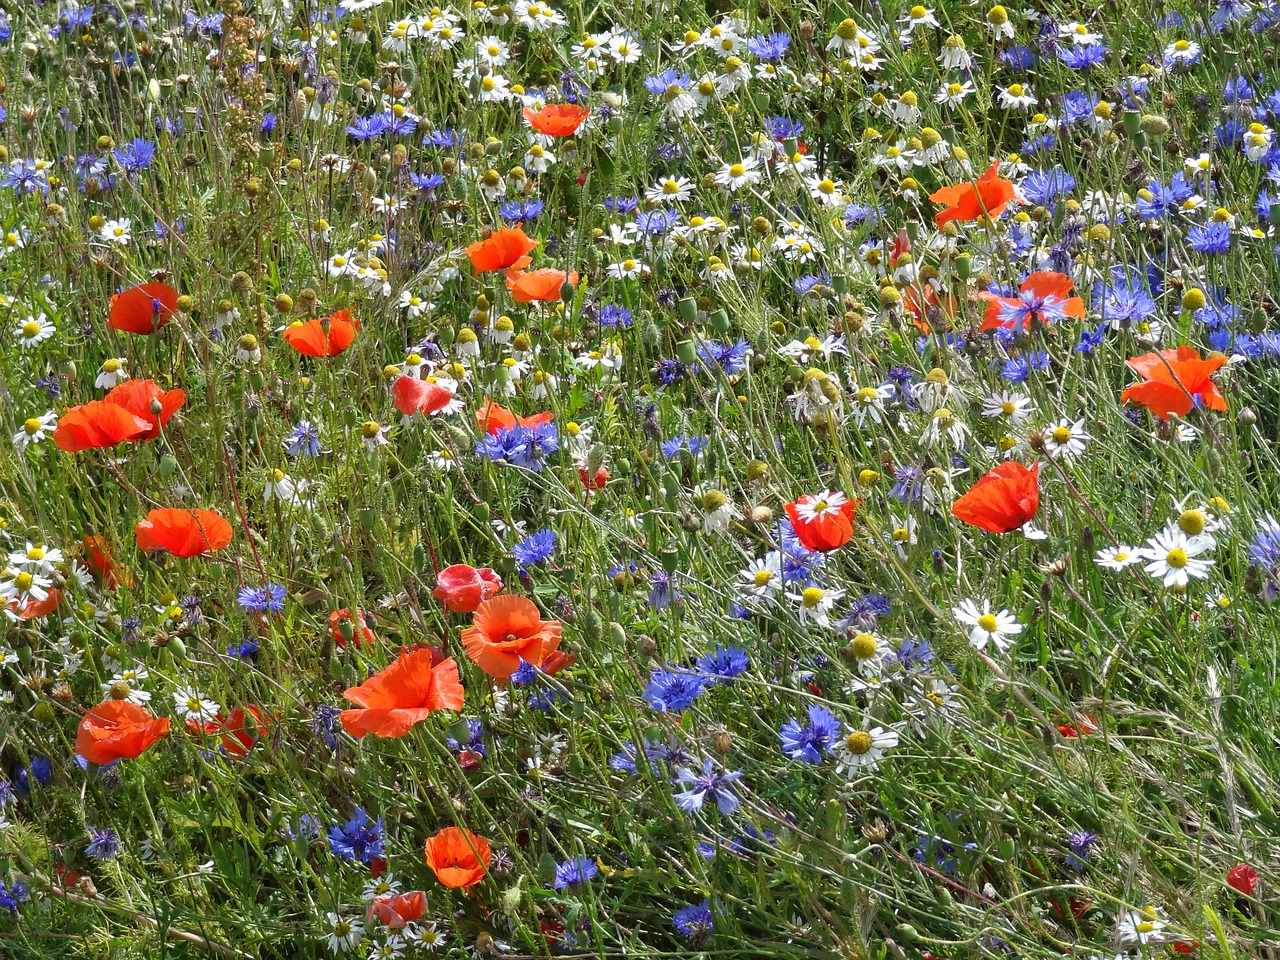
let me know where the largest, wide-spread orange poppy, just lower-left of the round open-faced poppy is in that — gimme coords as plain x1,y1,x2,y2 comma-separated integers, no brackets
339,648,463,739
